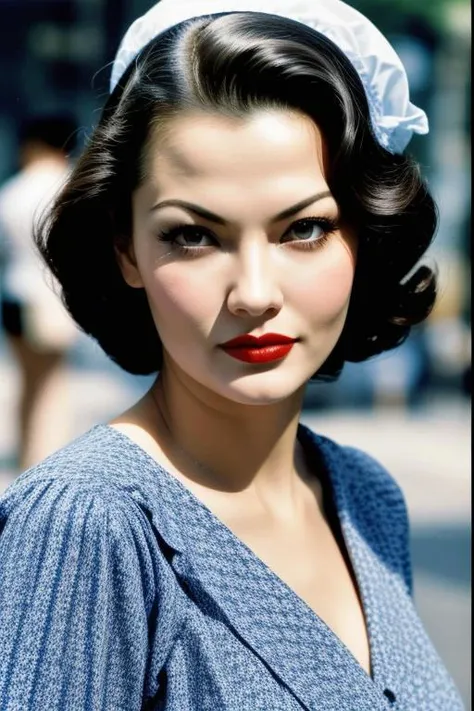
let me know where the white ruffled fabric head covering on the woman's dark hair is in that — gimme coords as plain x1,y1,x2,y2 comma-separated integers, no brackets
110,0,428,153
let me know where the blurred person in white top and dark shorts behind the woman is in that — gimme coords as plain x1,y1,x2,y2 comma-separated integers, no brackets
0,115,78,470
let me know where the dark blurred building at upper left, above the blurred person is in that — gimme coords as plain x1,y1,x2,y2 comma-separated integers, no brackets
0,0,153,181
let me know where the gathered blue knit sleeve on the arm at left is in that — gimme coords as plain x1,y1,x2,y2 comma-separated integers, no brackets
0,481,161,711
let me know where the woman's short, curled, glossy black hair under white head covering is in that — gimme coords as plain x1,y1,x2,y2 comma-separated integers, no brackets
36,13,437,379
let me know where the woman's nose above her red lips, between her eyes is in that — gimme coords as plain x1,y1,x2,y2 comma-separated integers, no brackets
227,239,283,318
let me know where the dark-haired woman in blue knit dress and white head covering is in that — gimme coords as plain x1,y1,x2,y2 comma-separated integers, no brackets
0,0,461,711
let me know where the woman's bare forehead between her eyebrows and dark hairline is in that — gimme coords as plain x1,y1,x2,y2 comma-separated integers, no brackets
145,109,325,185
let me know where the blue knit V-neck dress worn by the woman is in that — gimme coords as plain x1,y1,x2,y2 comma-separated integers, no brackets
0,425,463,711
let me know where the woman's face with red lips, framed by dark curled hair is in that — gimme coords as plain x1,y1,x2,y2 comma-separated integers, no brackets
121,110,356,405
